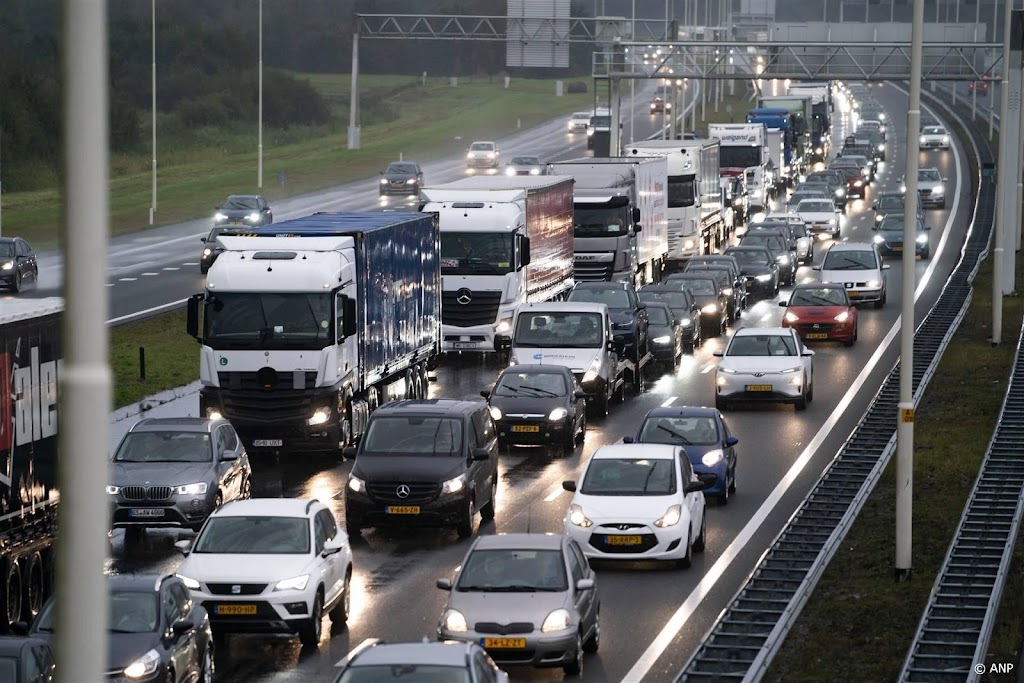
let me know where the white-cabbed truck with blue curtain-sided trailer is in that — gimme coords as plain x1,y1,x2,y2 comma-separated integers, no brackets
186,213,441,456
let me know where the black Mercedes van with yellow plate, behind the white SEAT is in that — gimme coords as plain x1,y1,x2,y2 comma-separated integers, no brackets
342,399,498,539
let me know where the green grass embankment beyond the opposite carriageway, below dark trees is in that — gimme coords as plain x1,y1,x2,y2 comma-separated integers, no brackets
3,76,593,249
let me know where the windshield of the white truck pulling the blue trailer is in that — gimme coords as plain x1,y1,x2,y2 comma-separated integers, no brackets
204,292,334,350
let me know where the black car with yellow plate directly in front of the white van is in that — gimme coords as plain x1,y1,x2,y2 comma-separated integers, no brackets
480,365,587,454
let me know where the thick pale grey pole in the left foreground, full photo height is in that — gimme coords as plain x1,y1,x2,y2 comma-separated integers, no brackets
53,0,112,683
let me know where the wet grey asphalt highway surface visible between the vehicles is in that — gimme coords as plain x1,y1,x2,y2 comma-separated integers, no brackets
96,81,970,682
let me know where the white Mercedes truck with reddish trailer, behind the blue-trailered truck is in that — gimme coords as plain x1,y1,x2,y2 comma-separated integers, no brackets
421,176,574,353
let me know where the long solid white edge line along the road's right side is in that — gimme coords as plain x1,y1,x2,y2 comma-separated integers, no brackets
622,91,964,683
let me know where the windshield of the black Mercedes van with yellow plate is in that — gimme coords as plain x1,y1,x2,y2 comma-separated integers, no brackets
359,415,462,456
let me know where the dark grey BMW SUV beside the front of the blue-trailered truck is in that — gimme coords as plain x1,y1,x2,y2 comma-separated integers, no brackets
106,418,252,537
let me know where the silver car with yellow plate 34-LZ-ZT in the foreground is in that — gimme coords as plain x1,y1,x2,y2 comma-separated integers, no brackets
437,533,601,676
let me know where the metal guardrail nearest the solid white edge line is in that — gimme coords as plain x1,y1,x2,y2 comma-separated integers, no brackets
676,92,995,683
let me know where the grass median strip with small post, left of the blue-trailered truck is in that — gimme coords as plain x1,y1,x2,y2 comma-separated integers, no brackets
110,309,199,409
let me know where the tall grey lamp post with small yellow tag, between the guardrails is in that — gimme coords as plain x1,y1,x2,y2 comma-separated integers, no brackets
895,0,925,581
